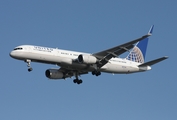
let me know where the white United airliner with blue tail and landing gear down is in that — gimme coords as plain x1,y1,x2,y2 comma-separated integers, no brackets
10,25,168,84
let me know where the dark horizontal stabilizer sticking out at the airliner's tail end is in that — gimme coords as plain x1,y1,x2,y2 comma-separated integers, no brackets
138,56,168,67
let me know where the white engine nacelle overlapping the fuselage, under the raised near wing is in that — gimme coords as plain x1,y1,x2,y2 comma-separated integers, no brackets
78,54,97,64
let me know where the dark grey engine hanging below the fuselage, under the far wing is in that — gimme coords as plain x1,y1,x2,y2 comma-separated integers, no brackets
45,69,64,79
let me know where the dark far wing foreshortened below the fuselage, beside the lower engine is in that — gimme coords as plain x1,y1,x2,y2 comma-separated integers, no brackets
58,67,88,78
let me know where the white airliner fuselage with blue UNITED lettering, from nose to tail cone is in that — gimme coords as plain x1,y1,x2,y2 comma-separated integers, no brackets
10,45,150,74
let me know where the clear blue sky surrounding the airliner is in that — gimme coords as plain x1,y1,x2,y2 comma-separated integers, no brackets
0,0,177,120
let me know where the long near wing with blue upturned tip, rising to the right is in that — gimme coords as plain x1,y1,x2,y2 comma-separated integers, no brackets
93,32,153,68
